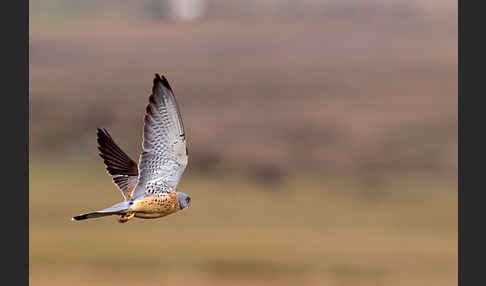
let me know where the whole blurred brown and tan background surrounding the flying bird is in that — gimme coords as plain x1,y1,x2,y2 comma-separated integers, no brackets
29,0,458,286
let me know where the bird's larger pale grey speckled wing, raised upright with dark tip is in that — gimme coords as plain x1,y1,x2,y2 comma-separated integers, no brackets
133,74,187,198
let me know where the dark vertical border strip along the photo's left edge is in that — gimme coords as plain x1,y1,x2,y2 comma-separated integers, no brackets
0,1,29,285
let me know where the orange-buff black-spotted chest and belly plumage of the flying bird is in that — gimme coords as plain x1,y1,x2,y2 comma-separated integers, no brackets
132,192,180,218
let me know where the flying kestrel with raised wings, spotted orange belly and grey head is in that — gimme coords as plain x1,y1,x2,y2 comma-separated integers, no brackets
72,73,191,223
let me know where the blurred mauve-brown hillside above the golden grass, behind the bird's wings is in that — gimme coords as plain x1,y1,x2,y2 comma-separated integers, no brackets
30,1,457,177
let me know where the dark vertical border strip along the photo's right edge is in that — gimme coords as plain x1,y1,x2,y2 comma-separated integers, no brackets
458,1,486,285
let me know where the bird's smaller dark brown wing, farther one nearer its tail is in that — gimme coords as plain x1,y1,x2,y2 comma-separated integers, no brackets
97,128,138,200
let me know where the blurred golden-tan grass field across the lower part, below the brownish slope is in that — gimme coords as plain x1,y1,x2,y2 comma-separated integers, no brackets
30,158,457,285
